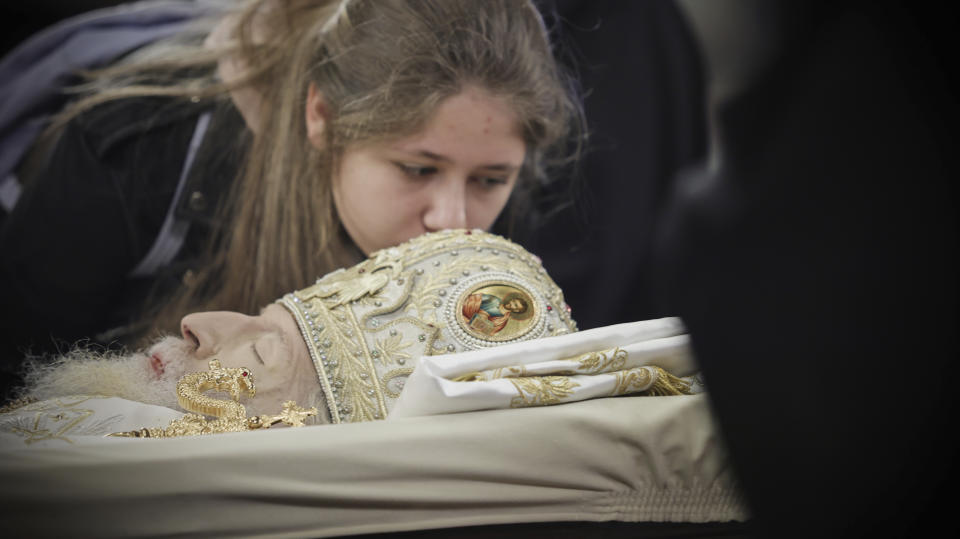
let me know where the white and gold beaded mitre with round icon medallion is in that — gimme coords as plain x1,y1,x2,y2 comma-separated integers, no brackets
278,230,577,423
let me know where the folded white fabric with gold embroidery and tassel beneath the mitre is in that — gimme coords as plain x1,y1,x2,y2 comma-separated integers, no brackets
389,318,703,418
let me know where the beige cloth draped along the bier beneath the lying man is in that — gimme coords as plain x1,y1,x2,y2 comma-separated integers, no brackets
0,395,747,537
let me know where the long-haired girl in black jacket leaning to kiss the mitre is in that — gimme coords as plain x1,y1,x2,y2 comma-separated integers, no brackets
0,0,582,380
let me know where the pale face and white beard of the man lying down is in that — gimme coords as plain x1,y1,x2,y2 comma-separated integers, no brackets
20,304,322,414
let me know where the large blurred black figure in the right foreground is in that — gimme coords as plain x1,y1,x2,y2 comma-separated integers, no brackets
655,1,958,537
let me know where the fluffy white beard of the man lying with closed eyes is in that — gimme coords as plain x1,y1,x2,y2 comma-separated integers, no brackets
22,337,193,409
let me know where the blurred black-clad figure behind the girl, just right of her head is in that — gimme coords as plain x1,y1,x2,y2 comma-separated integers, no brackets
515,0,707,329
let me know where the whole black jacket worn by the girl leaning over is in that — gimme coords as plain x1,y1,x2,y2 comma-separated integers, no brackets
0,98,247,394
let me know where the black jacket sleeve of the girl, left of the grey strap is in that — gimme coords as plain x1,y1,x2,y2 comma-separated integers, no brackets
0,102,196,380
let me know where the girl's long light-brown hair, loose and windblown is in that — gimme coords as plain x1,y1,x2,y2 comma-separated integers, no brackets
64,0,584,344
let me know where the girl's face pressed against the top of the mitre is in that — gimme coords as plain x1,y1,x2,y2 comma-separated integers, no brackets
307,87,526,254
